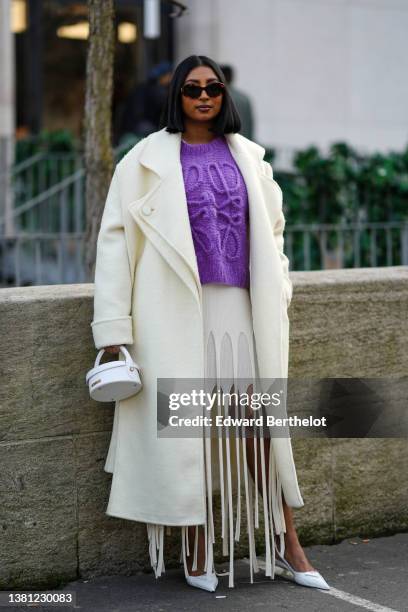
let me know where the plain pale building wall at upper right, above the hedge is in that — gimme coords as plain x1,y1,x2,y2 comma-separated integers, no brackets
175,0,408,151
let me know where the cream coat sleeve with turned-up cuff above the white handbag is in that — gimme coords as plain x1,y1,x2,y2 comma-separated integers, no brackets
91,170,133,349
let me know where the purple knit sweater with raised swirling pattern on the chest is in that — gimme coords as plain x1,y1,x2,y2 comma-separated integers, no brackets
180,136,249,288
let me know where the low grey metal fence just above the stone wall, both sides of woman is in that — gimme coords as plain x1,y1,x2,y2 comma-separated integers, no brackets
0,219,408,286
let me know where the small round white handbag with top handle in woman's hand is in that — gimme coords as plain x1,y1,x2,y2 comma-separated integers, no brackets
85,344,142,402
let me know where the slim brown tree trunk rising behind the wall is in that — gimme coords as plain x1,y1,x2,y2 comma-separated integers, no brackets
84,0,115,282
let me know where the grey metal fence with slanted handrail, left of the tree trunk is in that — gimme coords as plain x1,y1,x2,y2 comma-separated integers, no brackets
0,140,137,287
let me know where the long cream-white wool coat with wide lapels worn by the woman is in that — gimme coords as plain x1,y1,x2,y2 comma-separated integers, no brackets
91,128,304,525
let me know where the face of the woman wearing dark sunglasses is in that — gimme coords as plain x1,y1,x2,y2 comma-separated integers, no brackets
181,66,223,122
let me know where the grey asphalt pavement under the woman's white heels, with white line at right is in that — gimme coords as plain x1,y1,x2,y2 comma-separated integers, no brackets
0,534,408,612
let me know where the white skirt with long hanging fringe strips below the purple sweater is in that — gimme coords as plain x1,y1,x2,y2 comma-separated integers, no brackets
147,283,286,587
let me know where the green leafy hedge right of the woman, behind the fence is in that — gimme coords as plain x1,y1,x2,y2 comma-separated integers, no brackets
267,142,408,224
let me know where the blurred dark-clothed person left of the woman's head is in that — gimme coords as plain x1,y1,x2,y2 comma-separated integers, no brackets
115,61,172,143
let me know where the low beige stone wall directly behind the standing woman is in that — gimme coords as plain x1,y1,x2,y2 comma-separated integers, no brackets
0,267,408,589
